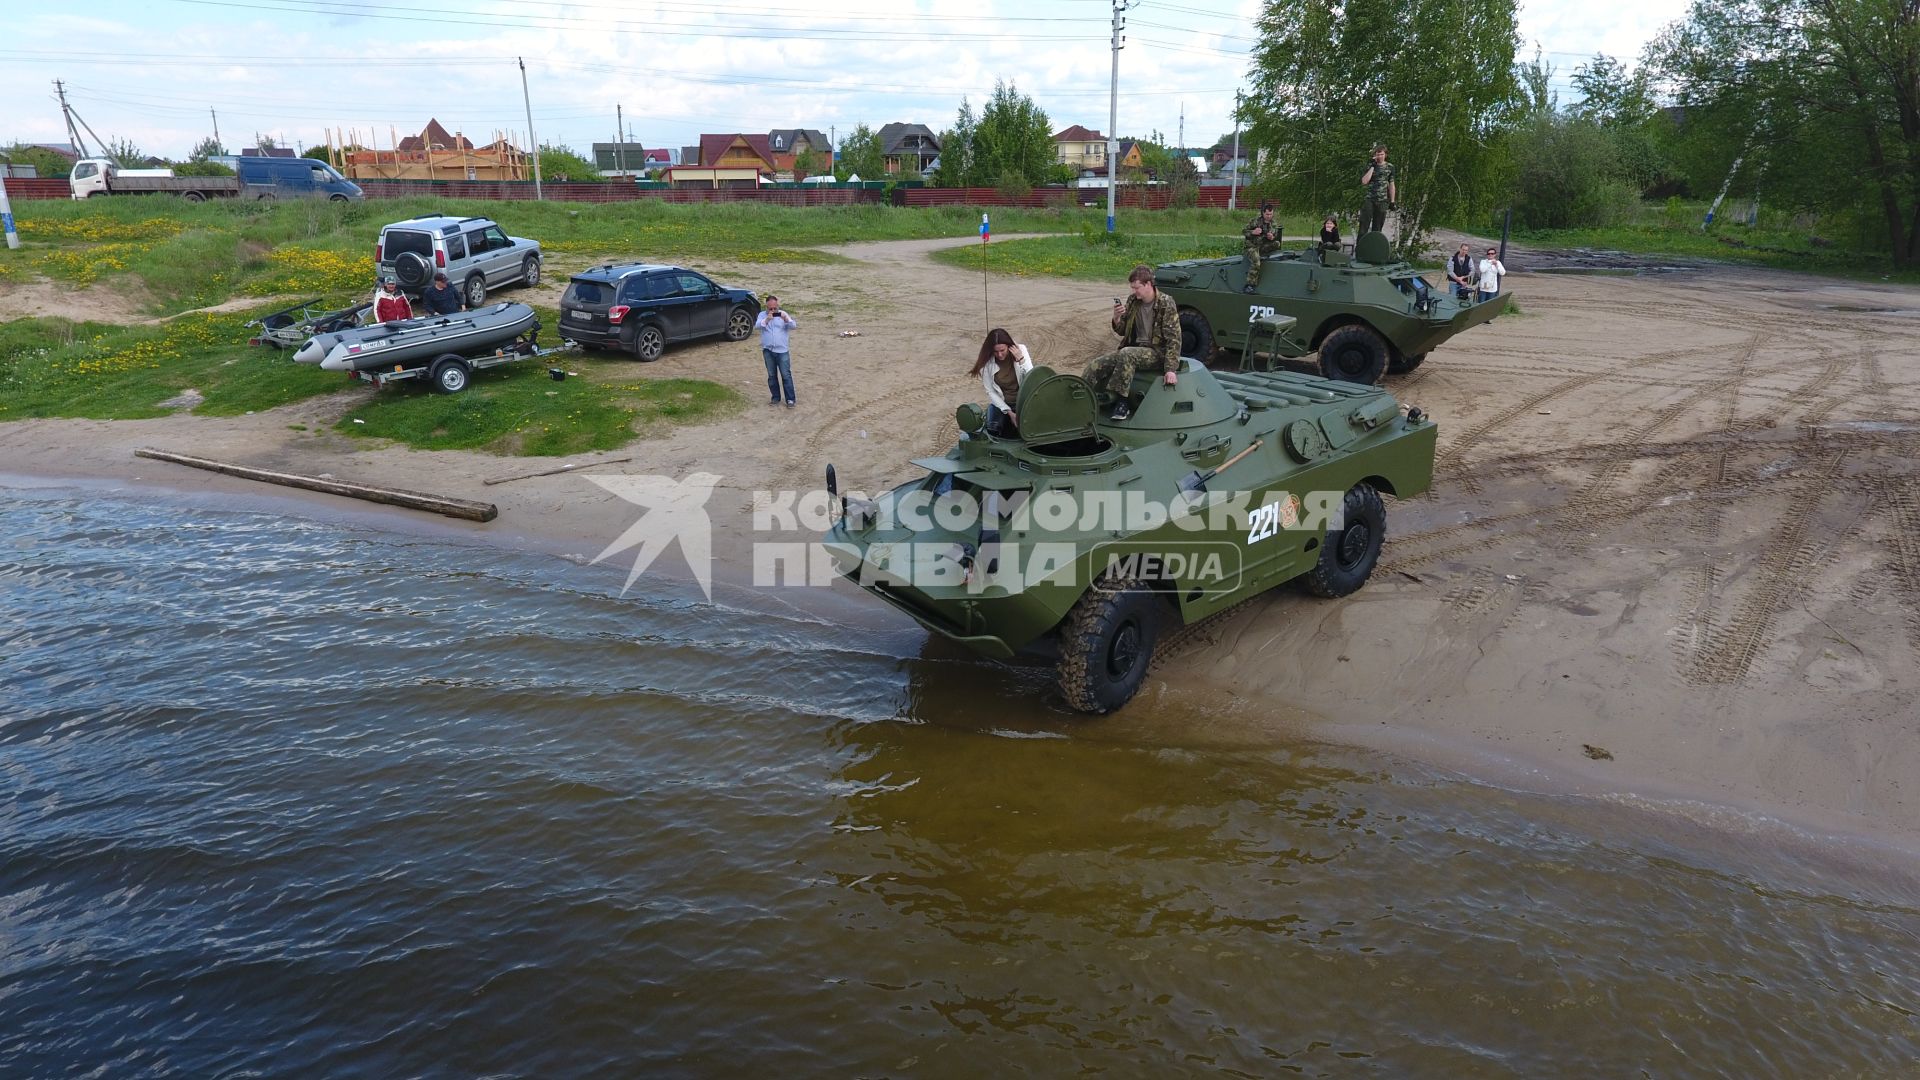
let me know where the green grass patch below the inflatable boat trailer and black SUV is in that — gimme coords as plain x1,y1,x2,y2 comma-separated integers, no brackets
336,357,747,457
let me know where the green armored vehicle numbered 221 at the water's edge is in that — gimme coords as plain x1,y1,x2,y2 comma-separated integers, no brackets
826,343,1436,713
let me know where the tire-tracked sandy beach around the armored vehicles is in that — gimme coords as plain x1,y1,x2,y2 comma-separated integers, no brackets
0,240,1920,849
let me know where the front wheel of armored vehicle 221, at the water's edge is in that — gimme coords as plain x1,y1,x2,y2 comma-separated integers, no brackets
1058,580,1165,713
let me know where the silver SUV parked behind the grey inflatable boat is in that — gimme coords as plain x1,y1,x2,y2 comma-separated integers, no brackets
372,215,540,307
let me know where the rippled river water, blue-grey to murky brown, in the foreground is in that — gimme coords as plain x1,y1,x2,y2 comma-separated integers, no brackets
0,492,1920,1076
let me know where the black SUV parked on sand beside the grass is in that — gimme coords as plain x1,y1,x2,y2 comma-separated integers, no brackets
561,263,760,359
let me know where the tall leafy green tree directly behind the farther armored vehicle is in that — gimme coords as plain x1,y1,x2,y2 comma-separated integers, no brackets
1240,0,1521,252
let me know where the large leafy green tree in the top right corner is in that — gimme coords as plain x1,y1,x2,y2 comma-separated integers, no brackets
1647,0,1920,269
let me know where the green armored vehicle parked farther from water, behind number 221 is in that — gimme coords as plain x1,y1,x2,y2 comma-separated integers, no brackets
1154,233,1507,386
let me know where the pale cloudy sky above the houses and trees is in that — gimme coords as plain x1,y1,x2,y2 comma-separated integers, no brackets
0,0,1682,158
